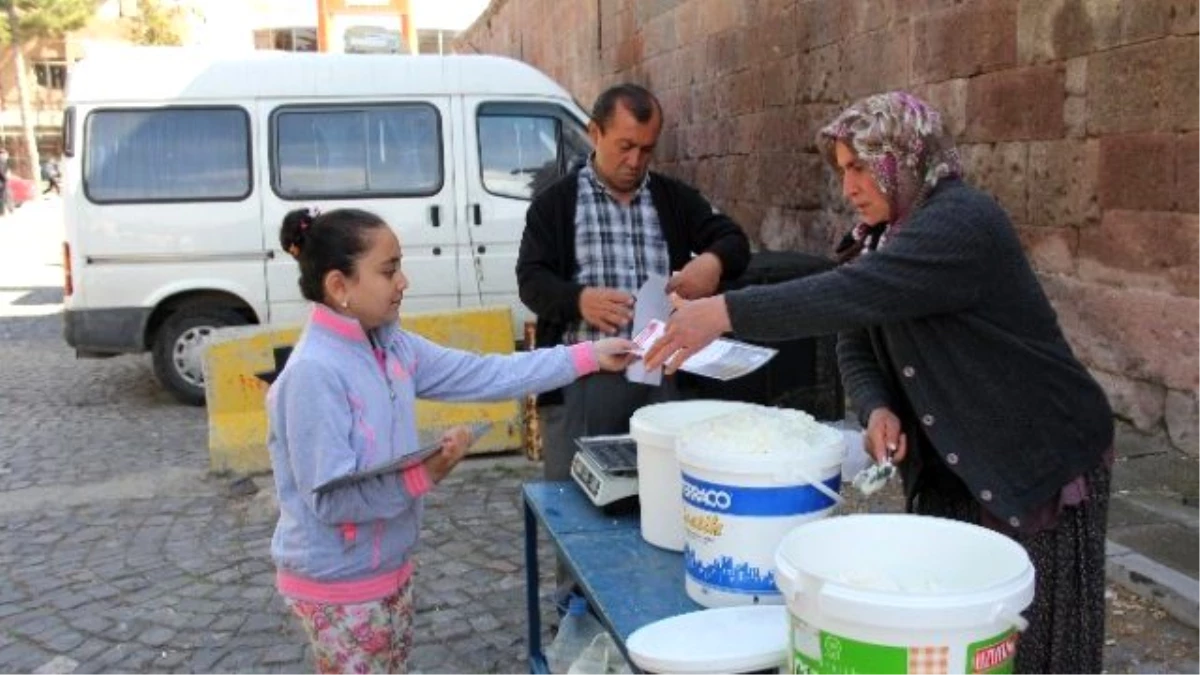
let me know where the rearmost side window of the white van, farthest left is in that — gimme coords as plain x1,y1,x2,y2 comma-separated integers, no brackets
83,107,252,204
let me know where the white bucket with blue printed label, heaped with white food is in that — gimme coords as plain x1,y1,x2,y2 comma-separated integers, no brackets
678,406,846,607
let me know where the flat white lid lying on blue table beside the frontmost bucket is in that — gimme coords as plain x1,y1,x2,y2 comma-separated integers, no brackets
625,605,788,673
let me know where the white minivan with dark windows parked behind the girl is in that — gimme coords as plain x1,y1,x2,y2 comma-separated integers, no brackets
62,48,590,404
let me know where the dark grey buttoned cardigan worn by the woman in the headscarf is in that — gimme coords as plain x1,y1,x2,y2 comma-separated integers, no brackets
726,180,1112,526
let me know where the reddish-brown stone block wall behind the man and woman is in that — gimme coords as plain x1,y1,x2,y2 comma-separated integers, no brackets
457,0,1200,456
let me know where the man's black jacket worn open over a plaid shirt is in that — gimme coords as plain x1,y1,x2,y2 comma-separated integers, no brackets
517,168,750,404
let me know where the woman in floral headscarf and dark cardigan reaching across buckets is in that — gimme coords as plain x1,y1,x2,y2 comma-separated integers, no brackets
646,92,1112,674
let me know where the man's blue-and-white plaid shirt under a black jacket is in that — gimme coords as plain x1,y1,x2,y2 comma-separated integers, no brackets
563,160,671,345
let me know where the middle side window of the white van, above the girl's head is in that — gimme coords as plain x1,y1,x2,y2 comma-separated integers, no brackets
271,103,443,199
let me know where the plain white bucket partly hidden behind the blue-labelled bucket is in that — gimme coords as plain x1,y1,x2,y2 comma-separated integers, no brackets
629,400,749,551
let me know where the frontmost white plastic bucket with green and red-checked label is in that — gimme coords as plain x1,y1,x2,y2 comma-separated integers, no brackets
775,514,1033,675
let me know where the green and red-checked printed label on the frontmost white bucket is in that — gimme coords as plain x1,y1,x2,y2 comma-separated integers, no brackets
792,617,1018,675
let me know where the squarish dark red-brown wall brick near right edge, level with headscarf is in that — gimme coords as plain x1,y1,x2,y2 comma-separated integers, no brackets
1099,133,1176,211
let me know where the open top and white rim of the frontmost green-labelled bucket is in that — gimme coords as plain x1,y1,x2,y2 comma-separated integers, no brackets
775,514,1033,629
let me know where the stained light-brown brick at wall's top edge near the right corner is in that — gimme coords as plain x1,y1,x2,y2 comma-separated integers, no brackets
1018,0,1172,64
